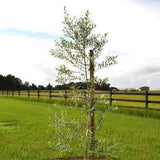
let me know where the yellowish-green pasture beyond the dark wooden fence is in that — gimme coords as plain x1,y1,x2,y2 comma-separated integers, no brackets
0,90,160,109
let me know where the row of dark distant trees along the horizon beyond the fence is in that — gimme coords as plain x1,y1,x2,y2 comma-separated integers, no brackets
0,74,113,90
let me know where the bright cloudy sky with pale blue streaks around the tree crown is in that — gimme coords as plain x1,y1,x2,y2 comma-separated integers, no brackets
0,0,160,89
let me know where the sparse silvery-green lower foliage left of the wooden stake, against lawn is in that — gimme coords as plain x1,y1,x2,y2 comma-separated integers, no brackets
48,105,87,154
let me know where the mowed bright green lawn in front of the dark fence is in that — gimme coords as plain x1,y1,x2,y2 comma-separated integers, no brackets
0,97,160,160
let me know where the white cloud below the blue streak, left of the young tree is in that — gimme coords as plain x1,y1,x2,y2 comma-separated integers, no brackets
0,36,57,85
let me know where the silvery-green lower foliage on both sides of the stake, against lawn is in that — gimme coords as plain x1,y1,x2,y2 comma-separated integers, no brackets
48,103,120,158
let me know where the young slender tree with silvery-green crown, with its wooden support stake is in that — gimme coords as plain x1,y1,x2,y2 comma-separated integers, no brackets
50,7,117,159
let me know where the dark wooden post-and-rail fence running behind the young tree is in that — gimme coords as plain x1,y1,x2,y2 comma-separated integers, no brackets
0,90,160,109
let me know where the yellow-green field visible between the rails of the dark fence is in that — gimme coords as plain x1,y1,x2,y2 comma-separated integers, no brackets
0,90,160,109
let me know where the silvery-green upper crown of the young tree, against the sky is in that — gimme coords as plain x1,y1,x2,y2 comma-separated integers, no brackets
50,7,117,83
